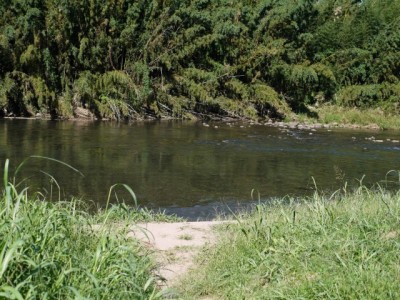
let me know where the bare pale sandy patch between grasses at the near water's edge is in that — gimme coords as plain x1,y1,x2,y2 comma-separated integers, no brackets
129,221,228,287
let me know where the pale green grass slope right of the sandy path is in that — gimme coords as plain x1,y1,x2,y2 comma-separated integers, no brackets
180,187,400,299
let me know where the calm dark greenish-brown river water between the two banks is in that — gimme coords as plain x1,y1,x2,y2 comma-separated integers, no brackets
0,120,400,219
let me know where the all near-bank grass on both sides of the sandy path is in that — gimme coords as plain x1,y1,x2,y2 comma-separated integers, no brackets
0,158,400,299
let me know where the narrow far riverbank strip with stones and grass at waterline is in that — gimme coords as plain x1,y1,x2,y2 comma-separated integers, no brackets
3,105,400,130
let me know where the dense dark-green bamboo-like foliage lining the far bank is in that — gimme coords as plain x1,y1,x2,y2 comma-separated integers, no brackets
0,0,400,119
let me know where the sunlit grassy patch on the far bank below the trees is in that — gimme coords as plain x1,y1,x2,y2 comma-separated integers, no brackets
297,105,400,129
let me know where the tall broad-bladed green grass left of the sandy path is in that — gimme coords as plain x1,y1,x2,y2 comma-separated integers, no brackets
0,160,161,299
